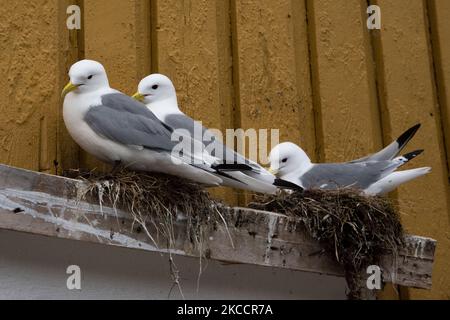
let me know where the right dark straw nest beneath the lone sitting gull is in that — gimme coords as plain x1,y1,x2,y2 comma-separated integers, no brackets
250,189,404,299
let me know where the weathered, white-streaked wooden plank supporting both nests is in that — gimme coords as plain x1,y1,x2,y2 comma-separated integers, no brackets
0,165,435,288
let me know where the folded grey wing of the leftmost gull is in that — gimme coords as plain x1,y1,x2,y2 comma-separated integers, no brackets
84,105,176,151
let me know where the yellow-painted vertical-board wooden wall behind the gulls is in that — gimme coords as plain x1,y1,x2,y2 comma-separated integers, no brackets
0,0,450,299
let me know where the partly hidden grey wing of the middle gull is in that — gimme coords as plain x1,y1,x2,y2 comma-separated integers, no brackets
164,114,260,170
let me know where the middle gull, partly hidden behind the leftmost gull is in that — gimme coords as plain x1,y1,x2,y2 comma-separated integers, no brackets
133,74,284,194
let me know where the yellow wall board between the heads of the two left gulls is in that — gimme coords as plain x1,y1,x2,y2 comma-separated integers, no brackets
80,0,151,170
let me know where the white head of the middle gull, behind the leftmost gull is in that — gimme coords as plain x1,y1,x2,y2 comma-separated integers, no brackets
133,73,177,105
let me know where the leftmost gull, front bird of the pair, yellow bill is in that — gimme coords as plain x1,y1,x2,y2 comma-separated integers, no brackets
62,60,239,186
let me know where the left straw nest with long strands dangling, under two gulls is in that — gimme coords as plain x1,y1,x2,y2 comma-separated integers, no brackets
65,169,228,298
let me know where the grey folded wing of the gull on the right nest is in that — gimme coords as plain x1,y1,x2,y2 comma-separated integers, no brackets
300,161,399,189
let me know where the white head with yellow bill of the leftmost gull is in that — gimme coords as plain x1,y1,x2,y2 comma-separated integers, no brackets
61,60,109,98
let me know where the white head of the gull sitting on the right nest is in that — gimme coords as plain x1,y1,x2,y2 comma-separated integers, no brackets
269,142,311,177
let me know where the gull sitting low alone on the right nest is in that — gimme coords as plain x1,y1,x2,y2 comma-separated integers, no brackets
269,142,431,195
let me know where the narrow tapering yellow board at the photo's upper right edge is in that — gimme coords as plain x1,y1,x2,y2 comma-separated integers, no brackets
427,0,450,181
